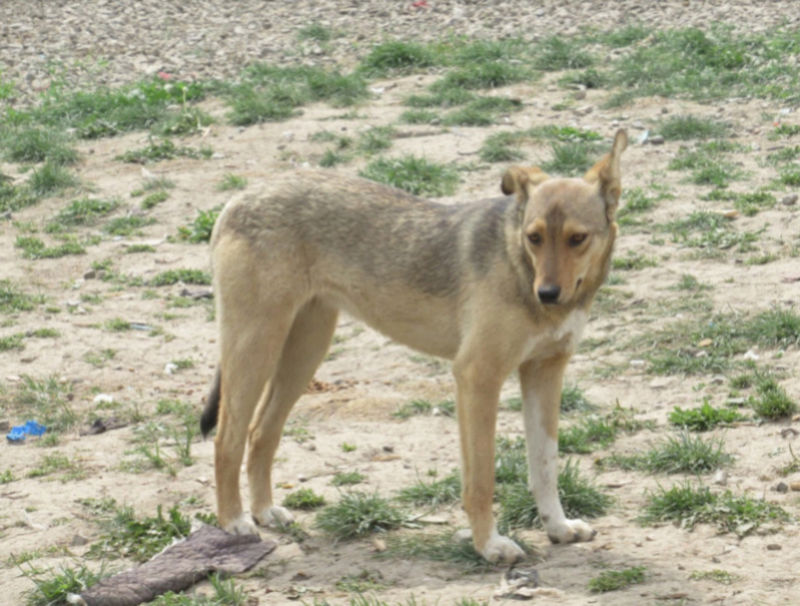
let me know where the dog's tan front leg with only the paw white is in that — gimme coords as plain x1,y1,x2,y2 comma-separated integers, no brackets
453,360,525,563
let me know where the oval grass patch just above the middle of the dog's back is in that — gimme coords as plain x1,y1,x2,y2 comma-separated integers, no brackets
359,156,458,196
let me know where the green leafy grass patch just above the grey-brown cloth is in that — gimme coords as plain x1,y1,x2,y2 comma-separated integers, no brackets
87,505,192,562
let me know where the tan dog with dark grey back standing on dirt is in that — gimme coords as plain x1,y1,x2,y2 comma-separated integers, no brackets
201,130,627,562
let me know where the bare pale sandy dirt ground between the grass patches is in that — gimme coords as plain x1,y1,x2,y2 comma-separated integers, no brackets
0,3,800,606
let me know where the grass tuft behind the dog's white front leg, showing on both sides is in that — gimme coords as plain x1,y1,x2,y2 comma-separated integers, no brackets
498,460,612,532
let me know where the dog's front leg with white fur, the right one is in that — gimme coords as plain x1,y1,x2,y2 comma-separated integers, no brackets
519,354,595,543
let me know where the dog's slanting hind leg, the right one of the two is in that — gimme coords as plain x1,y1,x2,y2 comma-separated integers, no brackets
247,299,338,525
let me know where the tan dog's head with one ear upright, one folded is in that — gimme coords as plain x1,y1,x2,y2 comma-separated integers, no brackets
501,130,628,306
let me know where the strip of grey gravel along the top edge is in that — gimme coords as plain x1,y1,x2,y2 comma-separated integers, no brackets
0,0,800,105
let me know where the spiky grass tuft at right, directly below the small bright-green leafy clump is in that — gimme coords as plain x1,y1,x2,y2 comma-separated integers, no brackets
611,431,732,474
